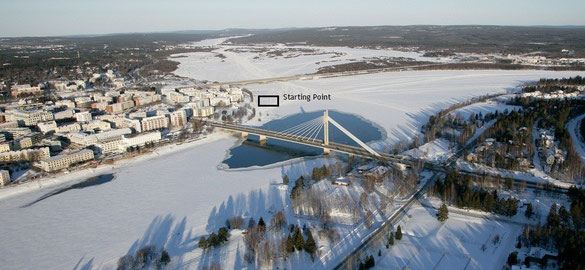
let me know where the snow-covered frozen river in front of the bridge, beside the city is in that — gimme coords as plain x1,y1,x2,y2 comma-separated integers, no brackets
0,133,338,269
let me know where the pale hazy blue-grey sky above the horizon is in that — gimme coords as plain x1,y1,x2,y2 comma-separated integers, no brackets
0,0,585,37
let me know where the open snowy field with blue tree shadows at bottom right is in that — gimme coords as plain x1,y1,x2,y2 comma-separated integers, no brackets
374,204,522,270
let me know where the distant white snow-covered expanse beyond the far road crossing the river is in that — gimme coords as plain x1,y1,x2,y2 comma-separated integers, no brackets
171,41,451,82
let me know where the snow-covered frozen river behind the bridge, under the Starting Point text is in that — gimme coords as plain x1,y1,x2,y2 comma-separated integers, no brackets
247,70,584,150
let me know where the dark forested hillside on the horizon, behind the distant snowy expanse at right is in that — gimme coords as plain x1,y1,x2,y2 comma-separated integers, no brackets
233,25,585,57
